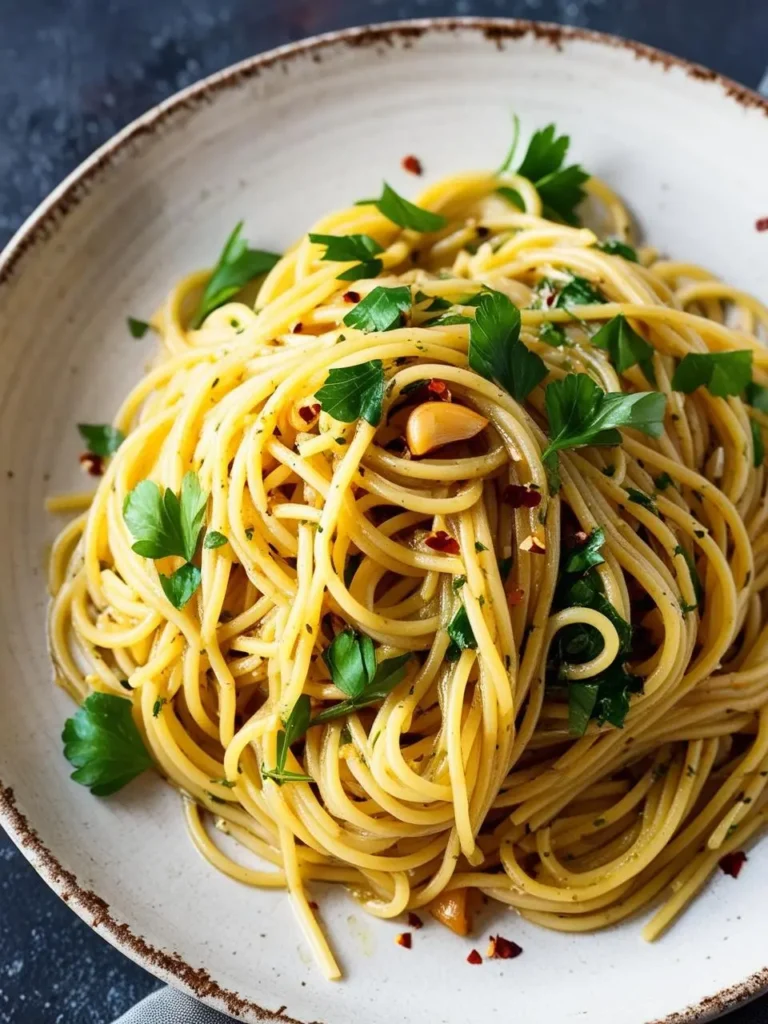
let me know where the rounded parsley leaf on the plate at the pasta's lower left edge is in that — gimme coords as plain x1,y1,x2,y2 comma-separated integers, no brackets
61,693,152,797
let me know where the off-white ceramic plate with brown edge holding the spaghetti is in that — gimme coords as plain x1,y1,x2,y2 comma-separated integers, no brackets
0,20,768,1024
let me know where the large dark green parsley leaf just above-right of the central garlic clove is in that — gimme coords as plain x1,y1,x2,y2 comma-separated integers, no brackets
469,291,549,402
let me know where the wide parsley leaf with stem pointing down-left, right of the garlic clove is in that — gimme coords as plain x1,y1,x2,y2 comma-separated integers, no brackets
542,374,667,481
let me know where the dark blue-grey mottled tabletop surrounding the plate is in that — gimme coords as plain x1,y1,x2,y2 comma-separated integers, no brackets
0,0,768,1024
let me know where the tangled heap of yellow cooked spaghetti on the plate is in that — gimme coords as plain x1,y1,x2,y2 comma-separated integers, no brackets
50,155,768,978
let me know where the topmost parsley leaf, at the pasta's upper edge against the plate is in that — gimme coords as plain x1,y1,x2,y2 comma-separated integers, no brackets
517,125,590,224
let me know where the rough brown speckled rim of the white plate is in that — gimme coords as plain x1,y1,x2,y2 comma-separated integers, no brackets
0,17,768,1024
